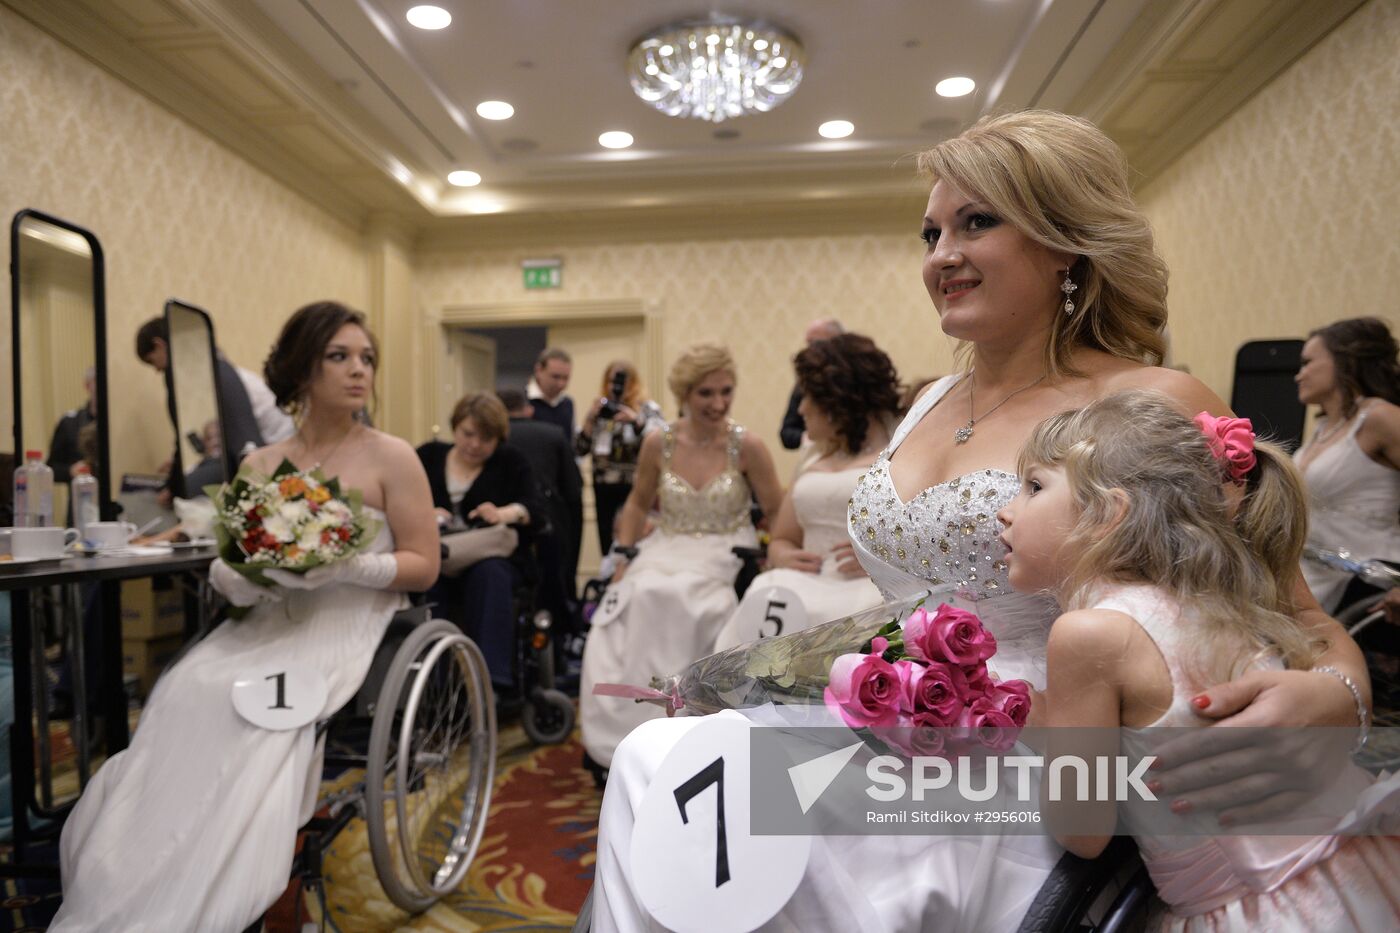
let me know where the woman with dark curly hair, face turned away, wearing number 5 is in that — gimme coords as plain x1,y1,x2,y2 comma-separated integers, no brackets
714,333,899,651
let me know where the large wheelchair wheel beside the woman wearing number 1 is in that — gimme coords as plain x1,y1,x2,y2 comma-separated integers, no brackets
365,619,496,913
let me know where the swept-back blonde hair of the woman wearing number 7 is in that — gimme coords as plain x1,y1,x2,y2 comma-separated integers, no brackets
918,111,1166,375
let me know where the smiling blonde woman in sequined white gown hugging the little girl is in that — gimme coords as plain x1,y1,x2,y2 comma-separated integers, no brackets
594,111,1369,933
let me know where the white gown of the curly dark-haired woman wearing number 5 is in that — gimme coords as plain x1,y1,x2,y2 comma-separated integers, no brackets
714,467,883,651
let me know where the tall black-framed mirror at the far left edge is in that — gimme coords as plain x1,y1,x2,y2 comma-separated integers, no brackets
10,210,113,524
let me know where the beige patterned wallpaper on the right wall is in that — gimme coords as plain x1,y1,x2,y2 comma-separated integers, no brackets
1141,0,1400,401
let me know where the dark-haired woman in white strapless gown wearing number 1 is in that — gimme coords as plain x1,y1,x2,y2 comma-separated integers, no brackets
52,301,438,930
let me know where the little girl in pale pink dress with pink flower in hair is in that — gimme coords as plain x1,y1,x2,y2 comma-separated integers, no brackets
998,392,1400,932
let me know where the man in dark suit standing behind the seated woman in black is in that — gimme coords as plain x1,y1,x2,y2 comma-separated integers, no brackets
496,389,584,610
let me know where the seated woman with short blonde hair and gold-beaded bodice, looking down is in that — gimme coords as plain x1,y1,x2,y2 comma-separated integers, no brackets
578,343,783,768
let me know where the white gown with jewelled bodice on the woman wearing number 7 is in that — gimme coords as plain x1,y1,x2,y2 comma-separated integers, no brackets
594,375,1063,933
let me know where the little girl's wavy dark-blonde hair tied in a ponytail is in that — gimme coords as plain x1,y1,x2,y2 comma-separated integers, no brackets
1018,391,1320,679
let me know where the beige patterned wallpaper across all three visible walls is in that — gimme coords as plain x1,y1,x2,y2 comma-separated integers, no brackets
0,0,1400,490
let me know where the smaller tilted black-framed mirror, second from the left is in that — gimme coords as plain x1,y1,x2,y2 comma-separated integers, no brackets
165,298,226,499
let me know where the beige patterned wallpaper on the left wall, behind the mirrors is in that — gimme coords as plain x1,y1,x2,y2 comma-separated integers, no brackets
0,7,370,474
